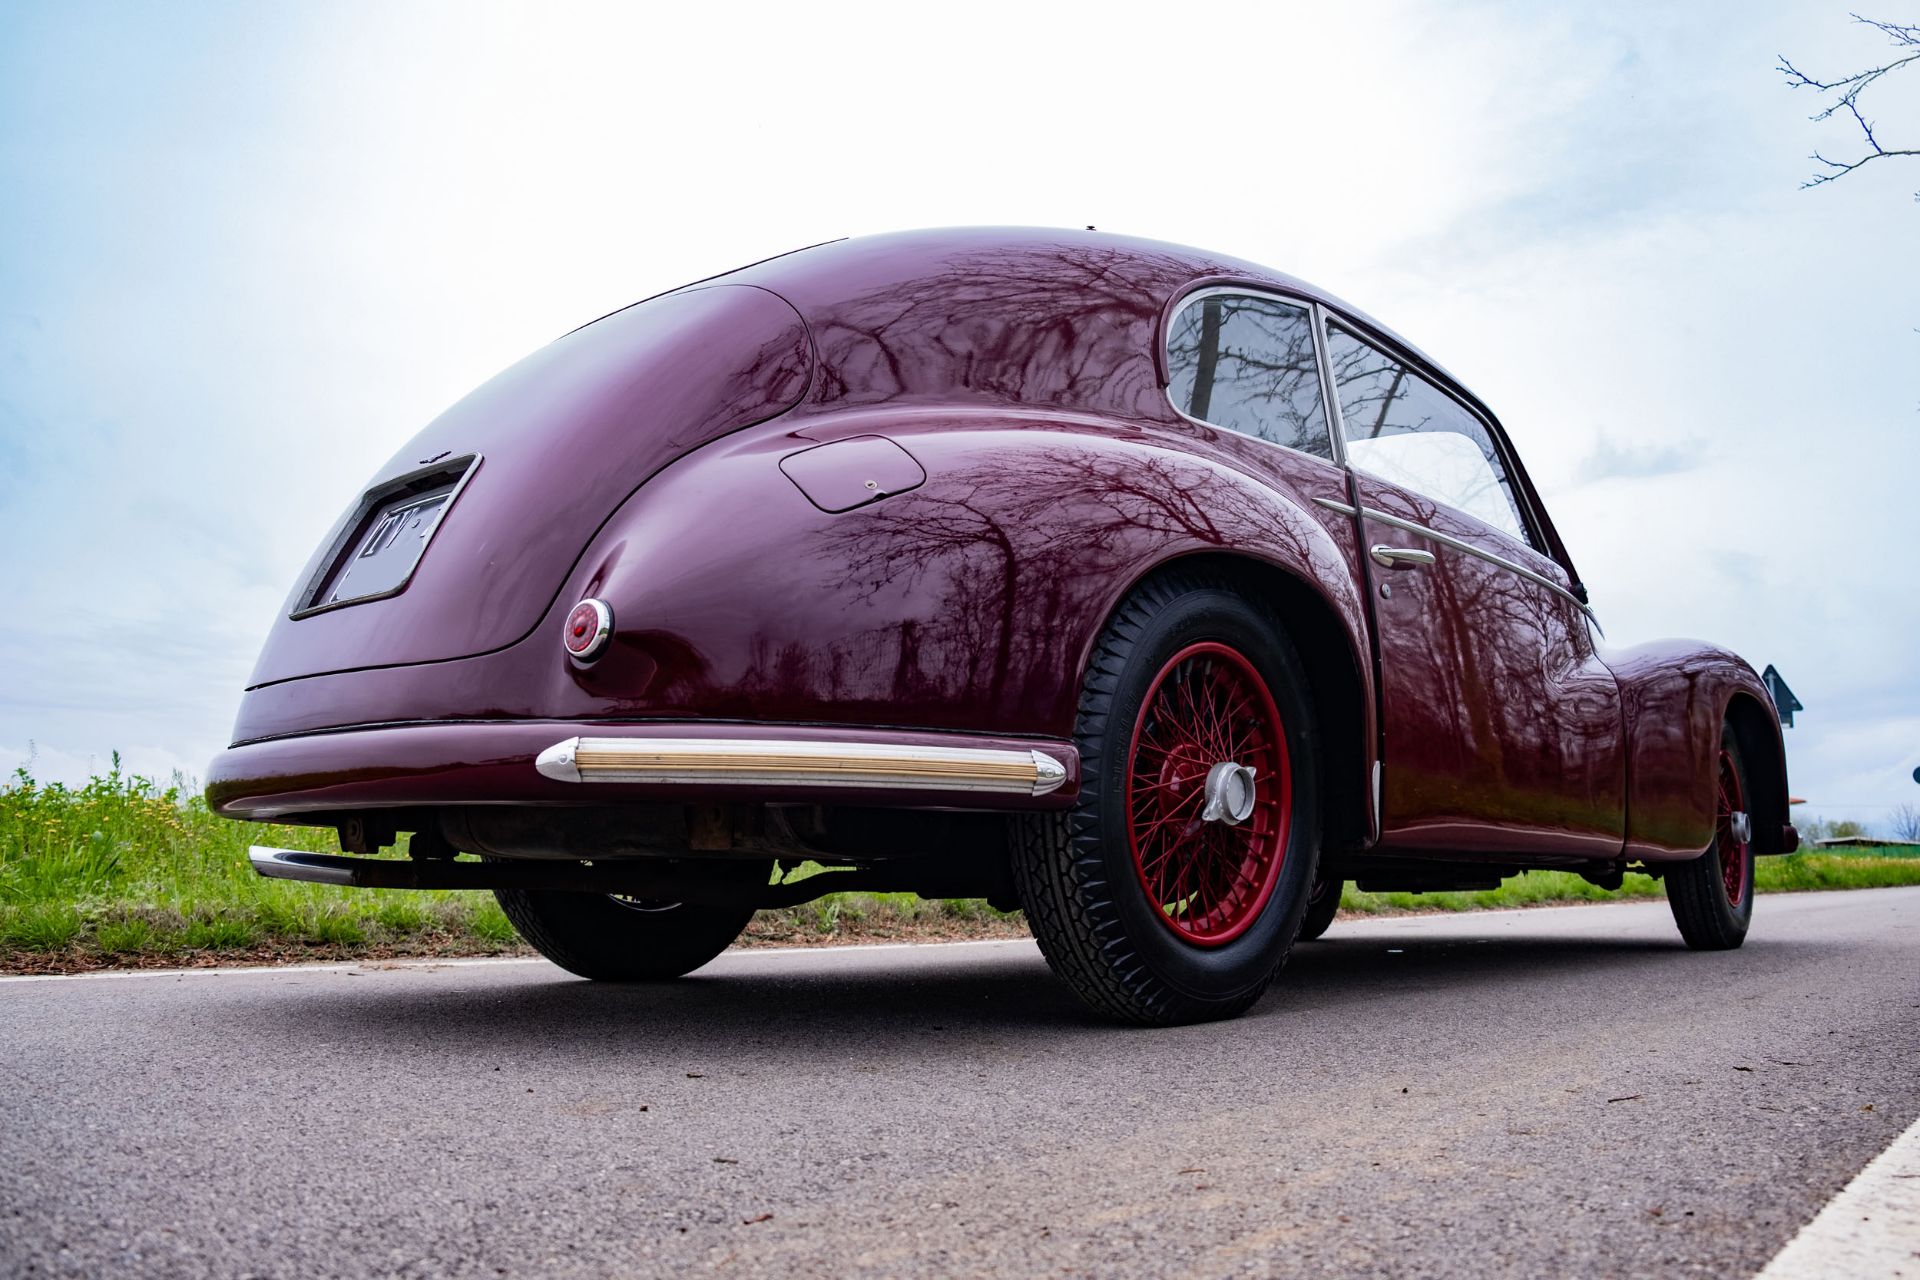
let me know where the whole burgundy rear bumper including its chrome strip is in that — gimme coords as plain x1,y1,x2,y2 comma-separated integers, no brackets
207,722,1079,821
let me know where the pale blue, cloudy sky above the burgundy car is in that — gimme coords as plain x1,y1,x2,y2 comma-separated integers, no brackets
0,0,1920,827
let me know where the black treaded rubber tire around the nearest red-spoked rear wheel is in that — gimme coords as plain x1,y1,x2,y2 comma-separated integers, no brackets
1014,576,1319,1027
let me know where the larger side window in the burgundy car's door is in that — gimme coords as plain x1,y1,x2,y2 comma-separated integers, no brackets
1327,324,1532,545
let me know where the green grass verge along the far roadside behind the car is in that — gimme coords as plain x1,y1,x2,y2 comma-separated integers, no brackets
0,756,1920,969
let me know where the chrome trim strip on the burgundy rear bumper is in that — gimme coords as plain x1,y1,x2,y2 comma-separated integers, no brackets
534,737,1068,796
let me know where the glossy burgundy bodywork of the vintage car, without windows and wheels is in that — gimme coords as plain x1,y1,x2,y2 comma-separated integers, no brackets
207,230,1795,887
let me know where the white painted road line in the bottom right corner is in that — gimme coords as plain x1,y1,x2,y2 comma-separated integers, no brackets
1755,1121,1920,1280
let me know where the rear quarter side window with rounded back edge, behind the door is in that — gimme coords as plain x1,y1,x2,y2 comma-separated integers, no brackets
1167,294,1332,459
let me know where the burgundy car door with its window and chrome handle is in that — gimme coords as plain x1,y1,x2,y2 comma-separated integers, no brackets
1327,322,1626,860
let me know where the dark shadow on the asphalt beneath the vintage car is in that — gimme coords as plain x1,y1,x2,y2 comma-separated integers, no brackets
255,933,1820,1067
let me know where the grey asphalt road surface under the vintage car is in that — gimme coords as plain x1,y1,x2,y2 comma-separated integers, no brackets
0,889,1920,1276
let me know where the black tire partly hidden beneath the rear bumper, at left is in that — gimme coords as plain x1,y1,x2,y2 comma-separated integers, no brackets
493,889,753,983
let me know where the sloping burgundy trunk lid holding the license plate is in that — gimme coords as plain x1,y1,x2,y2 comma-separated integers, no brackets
250,284,812,687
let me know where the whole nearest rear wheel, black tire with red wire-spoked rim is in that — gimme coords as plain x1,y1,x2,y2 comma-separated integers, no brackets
1014,578,1319,1025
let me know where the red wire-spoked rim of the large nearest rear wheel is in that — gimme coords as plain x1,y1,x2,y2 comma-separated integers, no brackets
1127,643,1292,946
